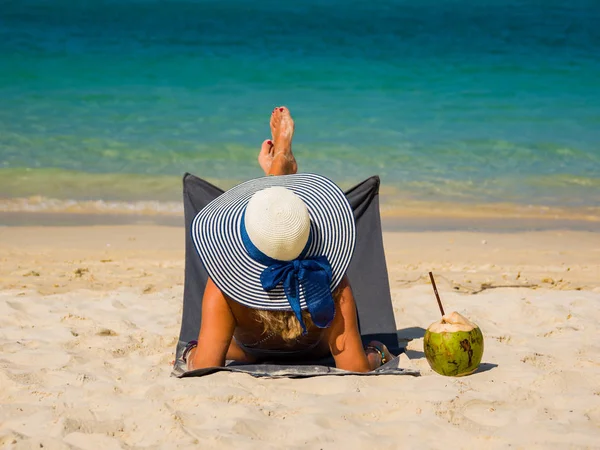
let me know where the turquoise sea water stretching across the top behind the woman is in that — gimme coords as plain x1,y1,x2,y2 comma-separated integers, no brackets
0,0,600,211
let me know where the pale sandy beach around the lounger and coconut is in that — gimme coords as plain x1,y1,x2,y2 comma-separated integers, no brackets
0,225,600,450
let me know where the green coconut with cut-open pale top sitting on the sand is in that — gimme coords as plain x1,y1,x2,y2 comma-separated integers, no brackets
424,311,483,377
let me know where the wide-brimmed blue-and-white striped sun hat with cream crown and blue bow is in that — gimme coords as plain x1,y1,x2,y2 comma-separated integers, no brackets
192,173,356,329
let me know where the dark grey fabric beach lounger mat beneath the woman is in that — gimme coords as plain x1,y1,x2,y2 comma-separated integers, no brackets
173,173,418,378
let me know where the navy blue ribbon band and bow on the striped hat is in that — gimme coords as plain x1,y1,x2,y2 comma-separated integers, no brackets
240,214,335,334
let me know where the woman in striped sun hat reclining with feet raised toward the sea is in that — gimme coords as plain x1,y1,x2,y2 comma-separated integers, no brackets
183,107,393,372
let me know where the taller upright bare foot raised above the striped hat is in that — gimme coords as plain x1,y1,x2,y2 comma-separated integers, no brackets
268,106,298,175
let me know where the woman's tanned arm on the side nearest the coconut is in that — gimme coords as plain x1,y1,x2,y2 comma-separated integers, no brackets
328,277,381,372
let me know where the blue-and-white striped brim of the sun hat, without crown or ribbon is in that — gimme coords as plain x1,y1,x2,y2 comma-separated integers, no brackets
191,173,356,311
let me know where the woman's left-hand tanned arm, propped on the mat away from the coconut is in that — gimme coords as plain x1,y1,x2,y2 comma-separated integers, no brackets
187,278,236,370
